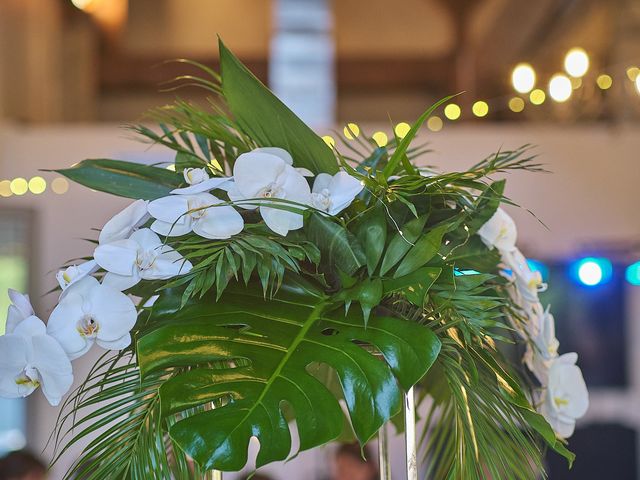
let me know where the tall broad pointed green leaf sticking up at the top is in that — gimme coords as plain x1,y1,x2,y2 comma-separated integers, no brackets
219,41,338,174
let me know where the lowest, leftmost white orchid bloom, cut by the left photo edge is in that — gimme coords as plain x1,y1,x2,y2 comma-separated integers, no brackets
0,315,73,406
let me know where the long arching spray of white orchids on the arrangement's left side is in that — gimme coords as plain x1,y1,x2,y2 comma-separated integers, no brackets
0,148,363,405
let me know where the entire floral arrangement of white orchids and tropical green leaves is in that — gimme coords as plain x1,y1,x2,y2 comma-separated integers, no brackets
0,43,588,479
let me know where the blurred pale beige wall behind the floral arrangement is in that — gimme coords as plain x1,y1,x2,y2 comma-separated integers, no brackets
0,124,640,479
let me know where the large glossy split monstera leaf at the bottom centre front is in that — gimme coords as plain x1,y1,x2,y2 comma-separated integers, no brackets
137,279,440,471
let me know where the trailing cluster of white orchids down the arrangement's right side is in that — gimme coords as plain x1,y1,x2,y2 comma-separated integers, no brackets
478,208,589,438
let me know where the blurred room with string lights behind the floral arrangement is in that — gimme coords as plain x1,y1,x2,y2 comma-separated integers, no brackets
0,0,640,480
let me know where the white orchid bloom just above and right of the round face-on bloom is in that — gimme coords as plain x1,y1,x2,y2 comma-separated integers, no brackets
93,228,192,291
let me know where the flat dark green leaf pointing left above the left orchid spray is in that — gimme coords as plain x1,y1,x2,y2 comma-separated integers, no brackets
55,159,180,200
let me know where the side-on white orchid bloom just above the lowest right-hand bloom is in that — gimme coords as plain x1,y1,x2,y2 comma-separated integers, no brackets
524,303,560,385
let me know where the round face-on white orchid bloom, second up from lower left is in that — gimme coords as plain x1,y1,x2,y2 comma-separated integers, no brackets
47,277,137,360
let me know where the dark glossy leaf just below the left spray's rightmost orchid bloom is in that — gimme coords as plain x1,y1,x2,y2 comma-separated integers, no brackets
305,213,367,275
